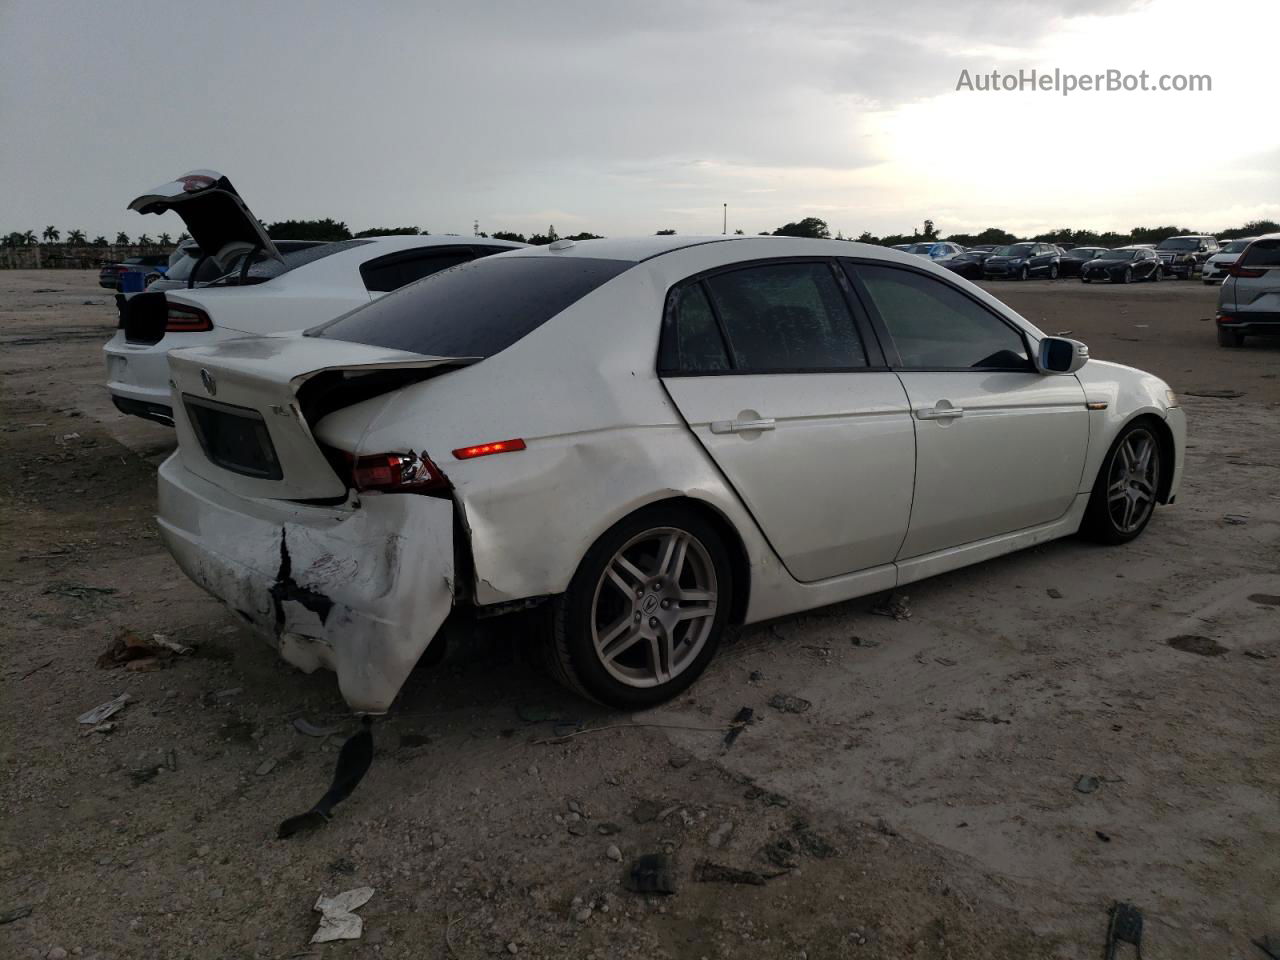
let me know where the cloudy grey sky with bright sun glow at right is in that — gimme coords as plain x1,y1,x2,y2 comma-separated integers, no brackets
0,0,1280,237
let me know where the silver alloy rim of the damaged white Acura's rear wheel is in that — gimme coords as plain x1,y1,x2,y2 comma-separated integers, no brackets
591,527,718,687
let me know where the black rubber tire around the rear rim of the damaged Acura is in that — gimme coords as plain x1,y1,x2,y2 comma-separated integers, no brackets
544,504,733,709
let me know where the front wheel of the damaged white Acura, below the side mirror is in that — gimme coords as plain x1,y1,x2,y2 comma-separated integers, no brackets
1080,420,1165,544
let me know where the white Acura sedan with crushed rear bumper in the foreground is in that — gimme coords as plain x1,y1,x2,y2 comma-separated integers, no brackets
159,237,1185,713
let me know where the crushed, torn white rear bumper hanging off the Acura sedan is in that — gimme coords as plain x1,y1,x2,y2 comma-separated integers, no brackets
156,451,454,714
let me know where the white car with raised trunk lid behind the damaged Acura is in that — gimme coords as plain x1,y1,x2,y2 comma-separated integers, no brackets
104,170,524,426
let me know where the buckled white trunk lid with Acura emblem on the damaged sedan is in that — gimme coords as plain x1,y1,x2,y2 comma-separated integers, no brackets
169,335,471,500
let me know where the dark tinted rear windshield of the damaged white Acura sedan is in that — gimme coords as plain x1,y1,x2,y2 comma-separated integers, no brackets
307,256,634,358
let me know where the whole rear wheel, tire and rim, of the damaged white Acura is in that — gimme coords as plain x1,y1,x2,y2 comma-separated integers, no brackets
547,504,733,709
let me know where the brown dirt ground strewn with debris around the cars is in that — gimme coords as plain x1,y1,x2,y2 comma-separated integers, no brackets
0,271,1280,960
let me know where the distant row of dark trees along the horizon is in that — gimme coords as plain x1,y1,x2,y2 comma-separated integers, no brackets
0,216,1280,248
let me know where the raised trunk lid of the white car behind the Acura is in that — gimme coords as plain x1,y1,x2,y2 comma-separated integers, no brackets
129,170,280,270
